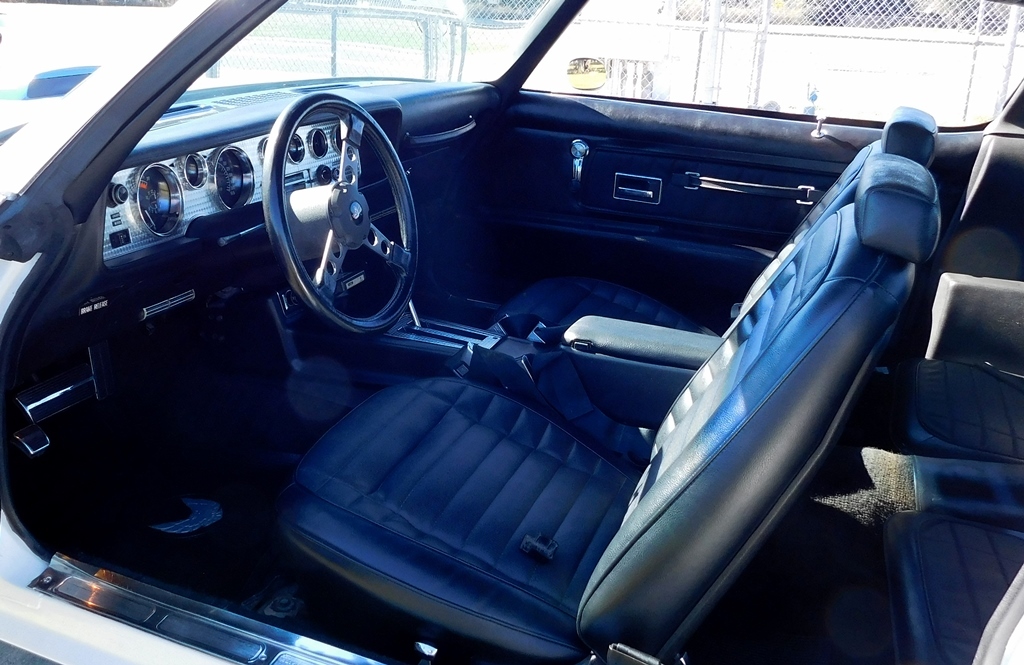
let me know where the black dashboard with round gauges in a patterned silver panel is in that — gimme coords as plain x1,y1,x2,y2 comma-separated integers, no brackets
11,81,499,380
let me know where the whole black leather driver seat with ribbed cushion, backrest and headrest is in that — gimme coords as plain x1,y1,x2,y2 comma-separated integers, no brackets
279,155,939,663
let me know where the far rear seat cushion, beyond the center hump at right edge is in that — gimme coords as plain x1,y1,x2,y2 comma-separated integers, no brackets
893,360,1024,462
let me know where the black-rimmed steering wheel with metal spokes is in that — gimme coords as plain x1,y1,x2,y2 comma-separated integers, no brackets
263,92,417,333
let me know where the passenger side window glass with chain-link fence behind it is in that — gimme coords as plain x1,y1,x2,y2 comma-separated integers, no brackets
525,0,1024,126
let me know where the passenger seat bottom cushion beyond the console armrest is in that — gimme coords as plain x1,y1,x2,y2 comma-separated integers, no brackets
495,277,715,335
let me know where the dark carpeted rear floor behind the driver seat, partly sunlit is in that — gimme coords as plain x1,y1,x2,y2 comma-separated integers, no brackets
688,446,913,665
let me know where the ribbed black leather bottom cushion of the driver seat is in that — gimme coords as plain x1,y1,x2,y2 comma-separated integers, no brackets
279,379,638,660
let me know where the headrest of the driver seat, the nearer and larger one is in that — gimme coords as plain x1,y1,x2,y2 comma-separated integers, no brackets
854,153,939,263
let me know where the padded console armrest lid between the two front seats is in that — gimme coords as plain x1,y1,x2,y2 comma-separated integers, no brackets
562,317,722,370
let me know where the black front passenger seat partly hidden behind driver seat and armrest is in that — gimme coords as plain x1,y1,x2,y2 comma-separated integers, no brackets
494,107,938,334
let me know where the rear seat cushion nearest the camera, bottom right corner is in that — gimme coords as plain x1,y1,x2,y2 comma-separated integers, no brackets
886,512,1024,665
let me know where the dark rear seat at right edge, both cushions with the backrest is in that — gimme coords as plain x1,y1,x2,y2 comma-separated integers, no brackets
885,275,1024,665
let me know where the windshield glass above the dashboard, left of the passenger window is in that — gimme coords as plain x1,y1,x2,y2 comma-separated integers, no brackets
194,0,548,93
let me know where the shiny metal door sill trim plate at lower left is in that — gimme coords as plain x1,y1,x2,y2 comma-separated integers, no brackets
29,553,383,665
